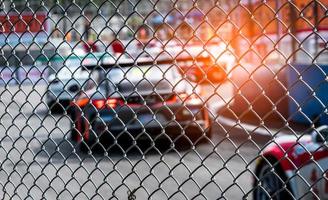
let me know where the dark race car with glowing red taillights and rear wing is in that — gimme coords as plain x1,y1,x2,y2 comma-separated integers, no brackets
69,58,211,150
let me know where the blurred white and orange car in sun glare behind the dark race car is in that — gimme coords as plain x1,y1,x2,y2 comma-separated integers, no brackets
125,40,236,84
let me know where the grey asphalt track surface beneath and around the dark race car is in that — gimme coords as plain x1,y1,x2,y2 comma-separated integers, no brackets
0,83,276,199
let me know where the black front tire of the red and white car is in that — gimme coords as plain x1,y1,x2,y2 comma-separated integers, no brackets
253,158,294,200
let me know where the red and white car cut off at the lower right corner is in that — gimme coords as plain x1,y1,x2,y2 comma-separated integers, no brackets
253,125,328,200
